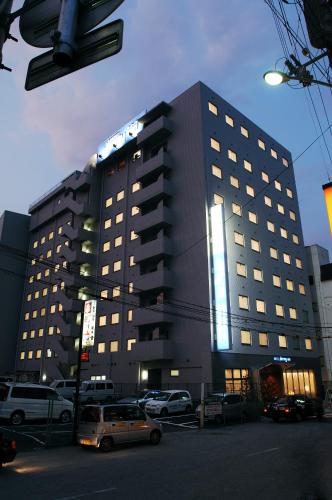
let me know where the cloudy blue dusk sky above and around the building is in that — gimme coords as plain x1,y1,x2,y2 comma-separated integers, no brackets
0,0,332,256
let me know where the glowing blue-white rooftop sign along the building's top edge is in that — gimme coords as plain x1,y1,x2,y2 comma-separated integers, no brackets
97,111,146,163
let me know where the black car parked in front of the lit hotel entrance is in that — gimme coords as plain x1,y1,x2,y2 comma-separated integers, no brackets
270,394,324,422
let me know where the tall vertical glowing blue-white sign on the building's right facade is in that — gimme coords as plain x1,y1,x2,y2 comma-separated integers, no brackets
210,204,229,350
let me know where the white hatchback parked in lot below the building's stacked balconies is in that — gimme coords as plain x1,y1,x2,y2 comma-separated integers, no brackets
145,390,193,417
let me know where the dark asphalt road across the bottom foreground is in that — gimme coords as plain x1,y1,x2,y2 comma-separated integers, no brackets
0,419,332,500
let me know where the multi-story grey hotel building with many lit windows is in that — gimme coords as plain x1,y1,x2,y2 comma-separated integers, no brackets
16,83,320,395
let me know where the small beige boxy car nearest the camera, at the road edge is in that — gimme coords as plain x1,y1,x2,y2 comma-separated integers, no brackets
78,404,162,452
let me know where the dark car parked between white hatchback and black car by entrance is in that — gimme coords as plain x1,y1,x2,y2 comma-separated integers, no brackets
195,392,247,423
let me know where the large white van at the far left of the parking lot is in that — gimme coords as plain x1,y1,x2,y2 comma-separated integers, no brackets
0,382,73,425
